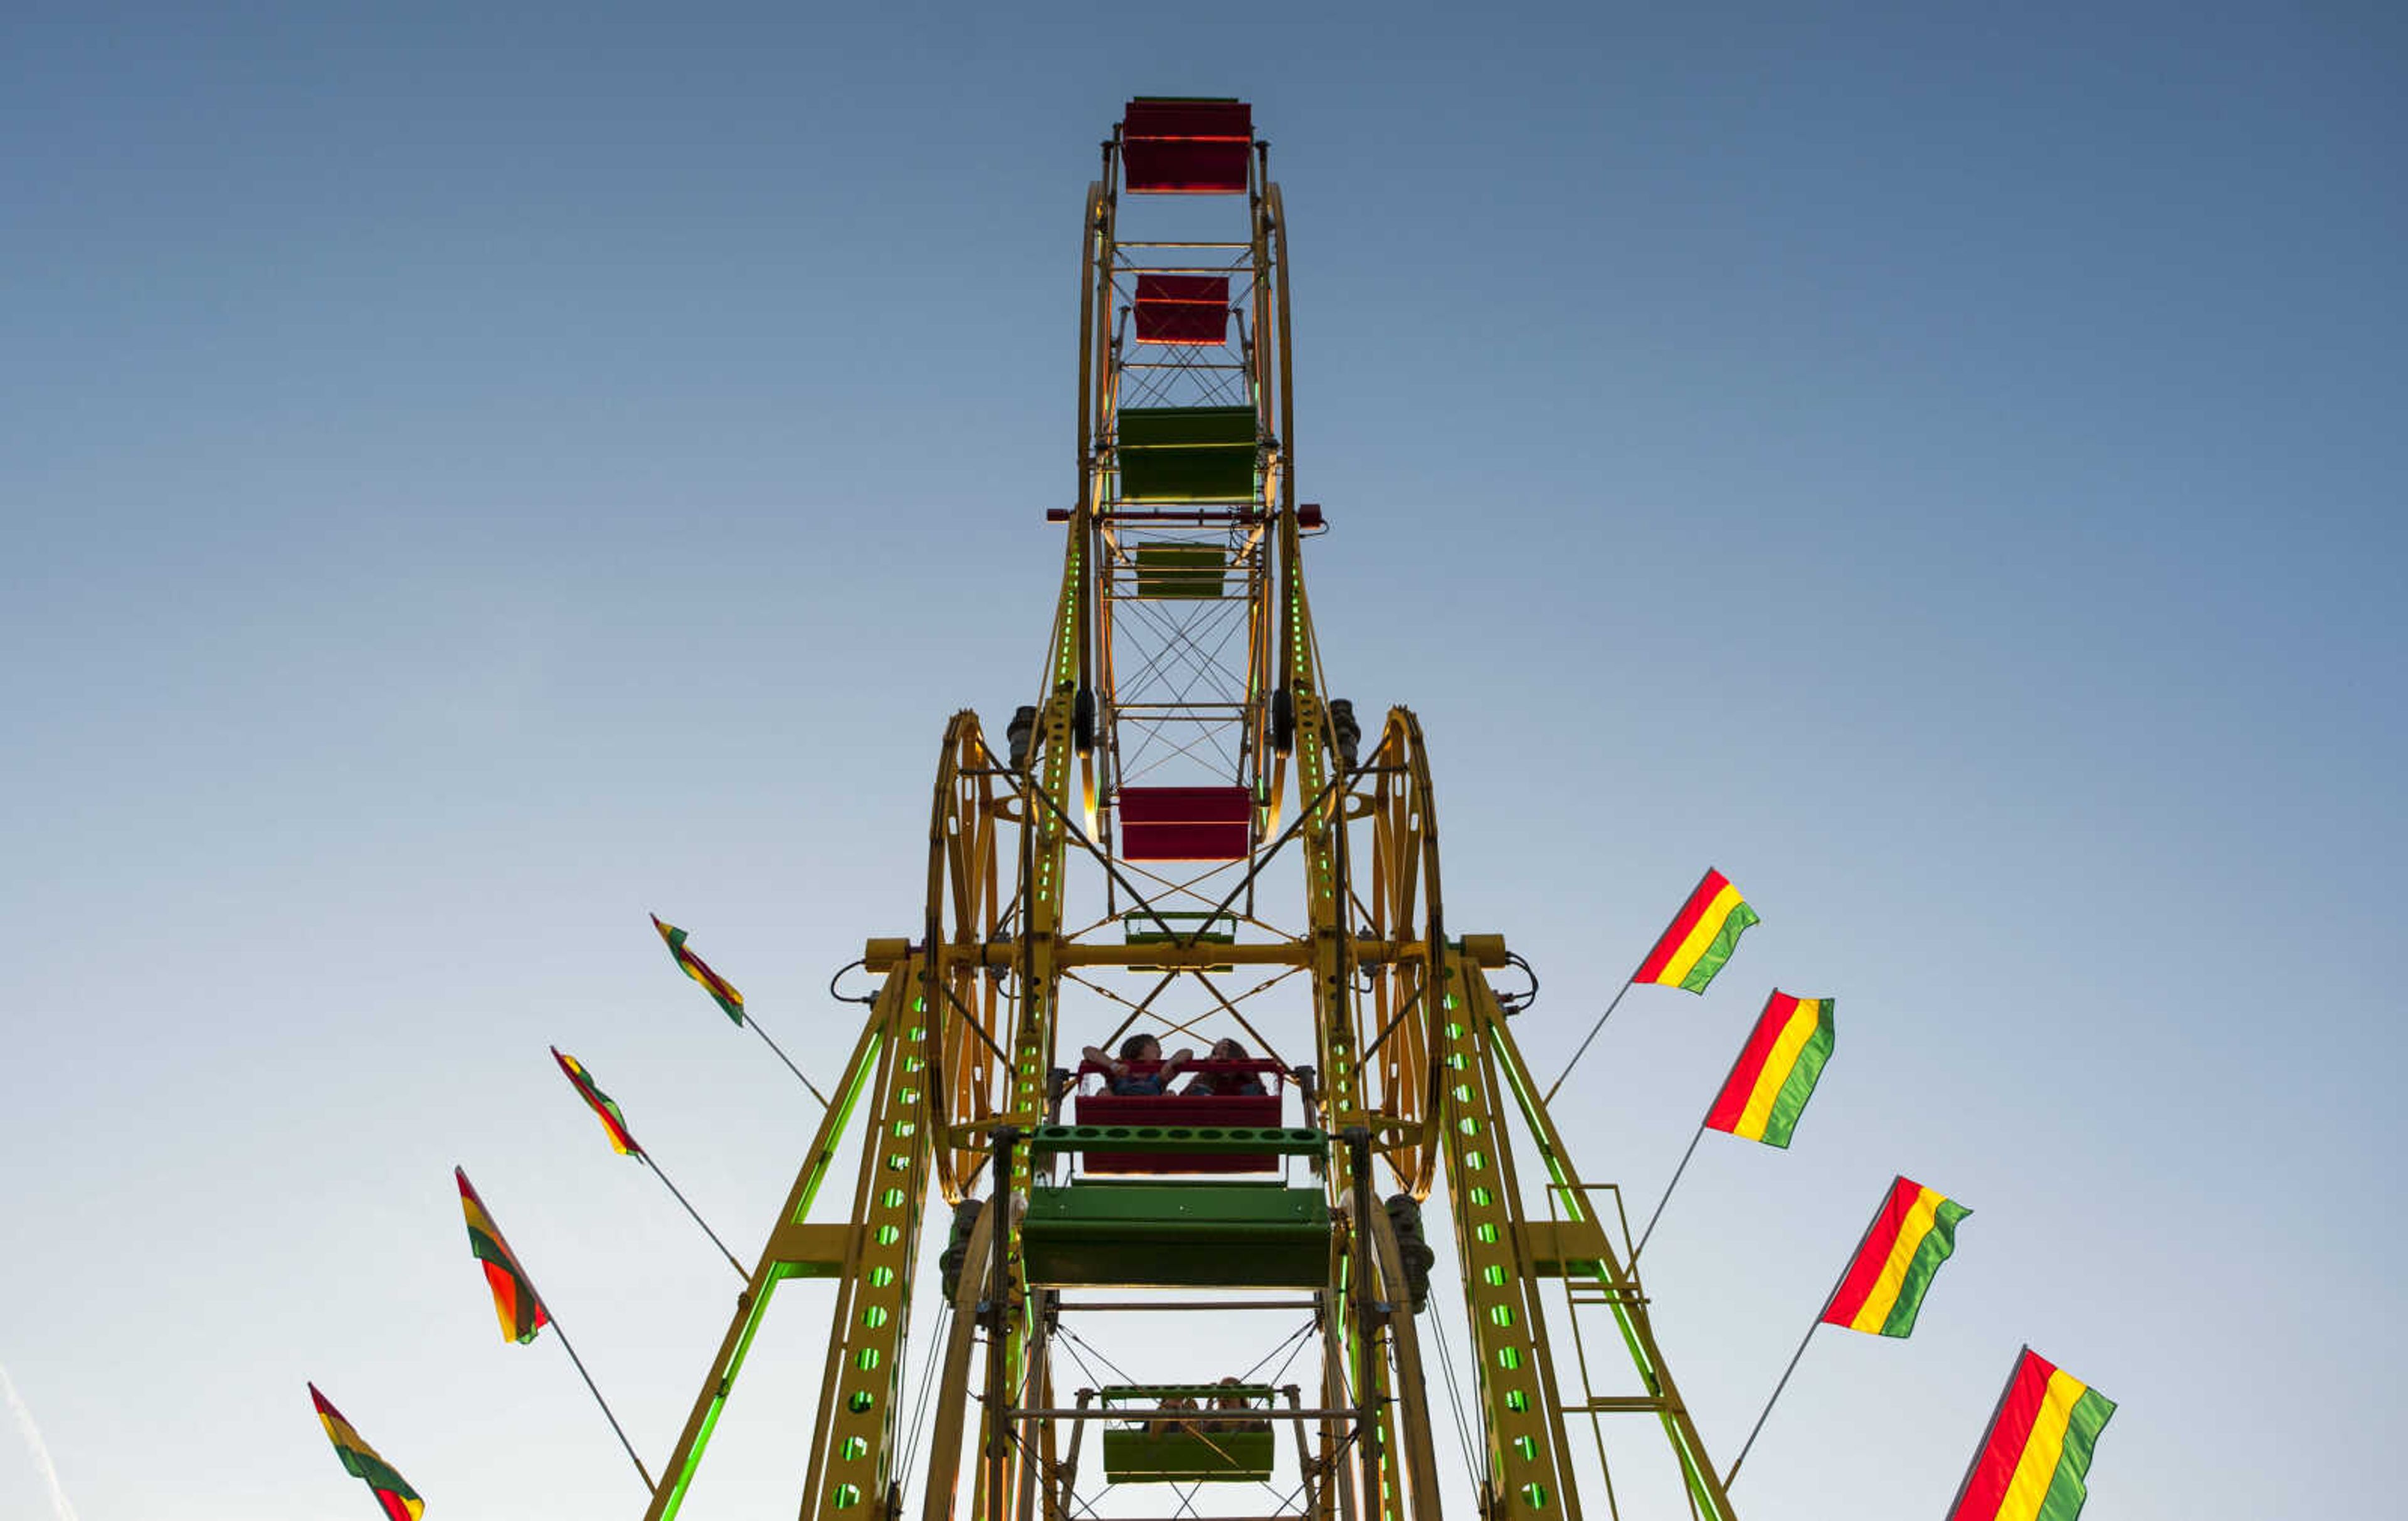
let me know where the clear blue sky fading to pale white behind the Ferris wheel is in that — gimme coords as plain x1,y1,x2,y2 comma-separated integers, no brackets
0,0,2408,1521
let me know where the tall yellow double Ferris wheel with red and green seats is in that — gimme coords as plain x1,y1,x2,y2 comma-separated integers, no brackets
645,98,1731,1521
